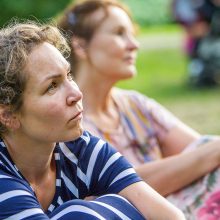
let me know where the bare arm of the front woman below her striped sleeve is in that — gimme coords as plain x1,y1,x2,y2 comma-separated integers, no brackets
119,182,185,220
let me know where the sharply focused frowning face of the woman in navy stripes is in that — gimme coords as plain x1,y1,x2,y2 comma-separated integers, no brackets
18,42,83,142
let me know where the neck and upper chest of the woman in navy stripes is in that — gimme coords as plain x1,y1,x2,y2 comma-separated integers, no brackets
3,134,55,183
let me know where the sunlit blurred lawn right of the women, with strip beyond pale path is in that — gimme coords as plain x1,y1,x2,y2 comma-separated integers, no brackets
118,27,220,134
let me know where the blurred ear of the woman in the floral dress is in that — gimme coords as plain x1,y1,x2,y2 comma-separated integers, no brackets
71,37,87,59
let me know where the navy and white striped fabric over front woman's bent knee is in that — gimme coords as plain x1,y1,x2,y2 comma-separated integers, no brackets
50,194,145,220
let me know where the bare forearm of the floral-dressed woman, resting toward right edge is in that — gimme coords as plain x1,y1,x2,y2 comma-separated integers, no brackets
136,138,220,196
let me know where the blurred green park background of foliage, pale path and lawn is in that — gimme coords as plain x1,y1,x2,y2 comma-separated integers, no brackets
0,0,220,134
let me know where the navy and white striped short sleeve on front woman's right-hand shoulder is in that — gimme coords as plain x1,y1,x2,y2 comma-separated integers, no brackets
80,132,141,195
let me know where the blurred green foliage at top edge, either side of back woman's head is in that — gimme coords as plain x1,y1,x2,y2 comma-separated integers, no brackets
0,0,174,27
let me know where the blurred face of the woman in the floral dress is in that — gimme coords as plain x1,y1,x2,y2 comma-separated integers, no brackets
87,6,138,80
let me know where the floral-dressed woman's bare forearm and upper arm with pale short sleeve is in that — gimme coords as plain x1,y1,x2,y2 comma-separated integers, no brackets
136,94,220,196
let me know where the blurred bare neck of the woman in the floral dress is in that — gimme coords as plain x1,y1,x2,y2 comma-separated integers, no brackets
77,70,120,131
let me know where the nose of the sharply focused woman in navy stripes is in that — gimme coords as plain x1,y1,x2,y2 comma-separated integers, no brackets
66,82,83,105
